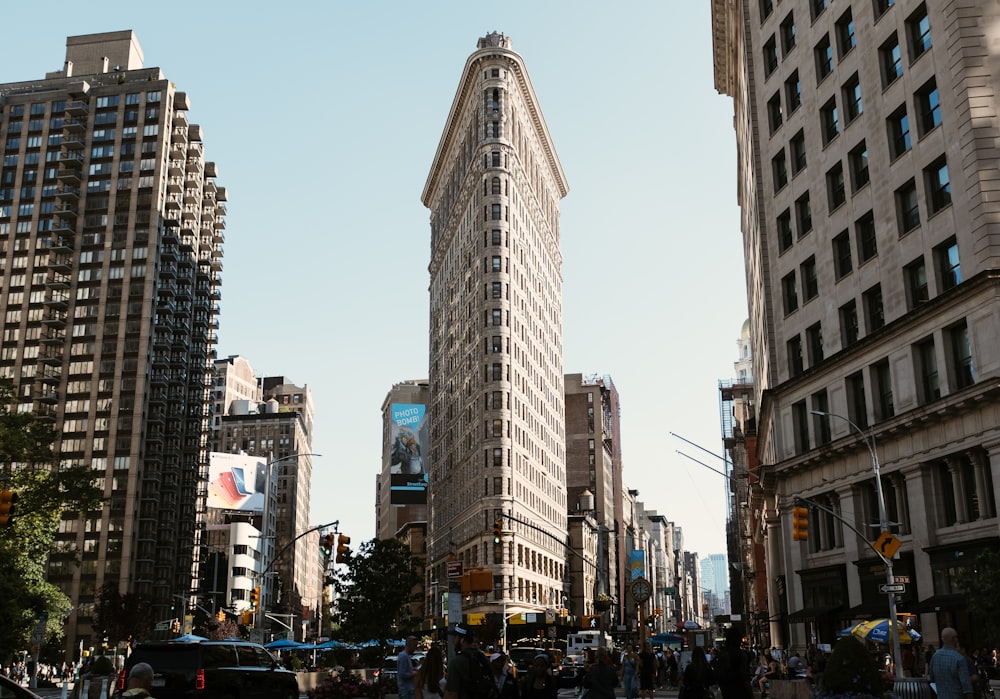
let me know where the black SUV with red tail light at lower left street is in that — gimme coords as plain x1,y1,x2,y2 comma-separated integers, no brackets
115,641,299,699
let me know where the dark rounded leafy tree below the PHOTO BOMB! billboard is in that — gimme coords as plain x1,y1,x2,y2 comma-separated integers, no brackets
333,539,421,645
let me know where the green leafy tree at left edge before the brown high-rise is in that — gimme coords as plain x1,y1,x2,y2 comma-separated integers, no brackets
0,379,103,658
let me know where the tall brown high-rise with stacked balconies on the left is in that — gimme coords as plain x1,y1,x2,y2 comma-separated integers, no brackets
0,31,226,648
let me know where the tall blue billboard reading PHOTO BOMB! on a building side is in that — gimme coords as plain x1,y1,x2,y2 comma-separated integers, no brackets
389,403,429,505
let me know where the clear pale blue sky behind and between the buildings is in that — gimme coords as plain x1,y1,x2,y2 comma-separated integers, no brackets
0,0,747,555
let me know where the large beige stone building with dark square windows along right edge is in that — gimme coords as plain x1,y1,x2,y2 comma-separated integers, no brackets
712,0,1000,647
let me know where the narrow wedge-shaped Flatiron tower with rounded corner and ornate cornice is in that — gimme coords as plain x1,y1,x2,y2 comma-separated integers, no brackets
422,33,568,624
